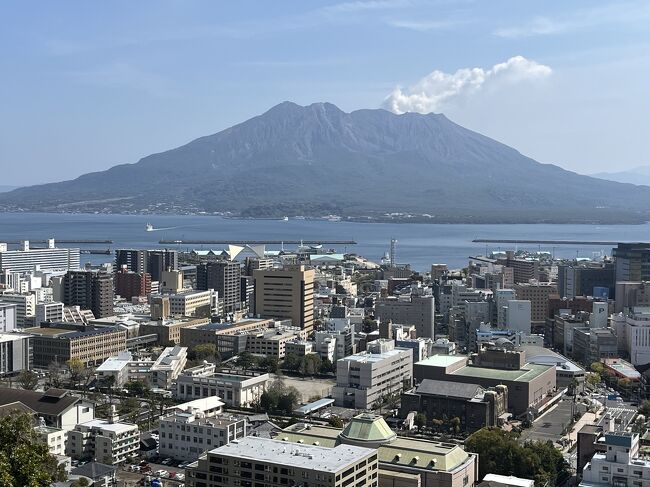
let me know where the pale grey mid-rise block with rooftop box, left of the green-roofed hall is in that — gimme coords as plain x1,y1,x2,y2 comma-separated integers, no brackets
332,340,413,409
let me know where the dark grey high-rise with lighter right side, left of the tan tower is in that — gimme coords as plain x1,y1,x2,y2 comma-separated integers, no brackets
196,260,241,313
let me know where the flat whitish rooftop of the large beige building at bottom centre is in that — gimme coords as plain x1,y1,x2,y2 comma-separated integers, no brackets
211,436,376,473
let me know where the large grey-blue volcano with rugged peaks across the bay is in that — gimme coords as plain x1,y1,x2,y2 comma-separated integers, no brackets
0,101,650,223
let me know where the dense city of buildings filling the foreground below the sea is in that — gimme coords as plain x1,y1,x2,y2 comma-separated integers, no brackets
0,237,650,487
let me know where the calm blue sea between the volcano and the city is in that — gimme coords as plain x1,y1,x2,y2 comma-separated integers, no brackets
0,213,650,270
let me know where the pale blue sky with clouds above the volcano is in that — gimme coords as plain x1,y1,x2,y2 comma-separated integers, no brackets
0,0,650,184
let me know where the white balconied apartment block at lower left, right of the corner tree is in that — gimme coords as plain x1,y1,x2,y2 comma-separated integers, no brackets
67,419,140,465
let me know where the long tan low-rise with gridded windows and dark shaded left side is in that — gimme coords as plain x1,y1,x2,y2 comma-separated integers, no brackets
25,323,127,367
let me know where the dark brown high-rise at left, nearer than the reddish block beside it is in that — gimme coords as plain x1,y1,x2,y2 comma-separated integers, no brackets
63,271,114,318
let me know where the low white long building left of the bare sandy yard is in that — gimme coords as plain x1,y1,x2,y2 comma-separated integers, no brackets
175,370,270,407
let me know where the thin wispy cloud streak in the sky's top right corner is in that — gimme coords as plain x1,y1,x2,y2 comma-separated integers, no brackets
493,0,650,39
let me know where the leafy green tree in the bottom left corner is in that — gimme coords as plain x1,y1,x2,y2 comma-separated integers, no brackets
0,413,67,487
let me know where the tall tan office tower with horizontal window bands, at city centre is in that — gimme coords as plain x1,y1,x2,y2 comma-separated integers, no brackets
253,265,315,333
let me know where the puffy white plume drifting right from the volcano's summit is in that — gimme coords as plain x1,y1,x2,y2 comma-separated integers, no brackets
383,56,552,113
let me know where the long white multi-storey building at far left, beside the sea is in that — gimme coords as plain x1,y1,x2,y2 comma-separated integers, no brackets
0,239,79,272
